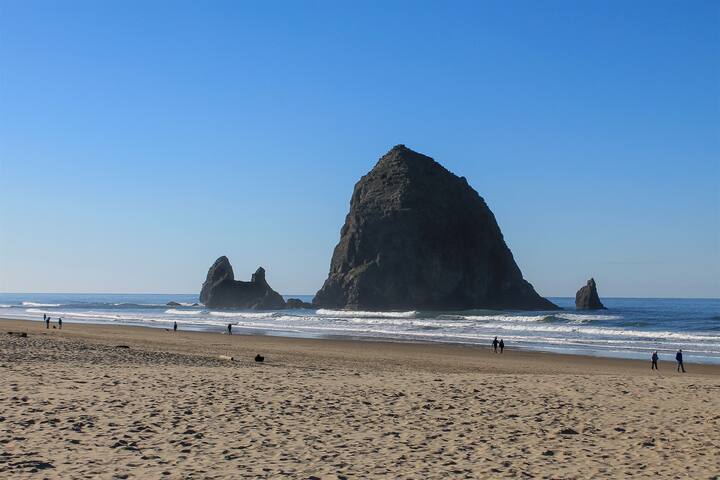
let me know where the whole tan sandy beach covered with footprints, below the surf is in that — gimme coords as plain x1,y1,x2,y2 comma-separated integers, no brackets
0,320,720,479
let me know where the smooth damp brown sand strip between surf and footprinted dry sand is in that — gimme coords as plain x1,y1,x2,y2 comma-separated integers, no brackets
0,318,720,376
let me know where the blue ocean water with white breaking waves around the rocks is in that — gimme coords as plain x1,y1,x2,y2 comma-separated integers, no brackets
0,293,720,364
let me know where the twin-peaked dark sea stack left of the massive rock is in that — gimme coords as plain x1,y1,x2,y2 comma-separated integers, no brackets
200,256,285,310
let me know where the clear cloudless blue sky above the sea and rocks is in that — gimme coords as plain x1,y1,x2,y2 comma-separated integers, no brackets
0,0,720,297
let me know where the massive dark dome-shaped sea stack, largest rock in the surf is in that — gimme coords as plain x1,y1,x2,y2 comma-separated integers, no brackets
313,145,558,310
